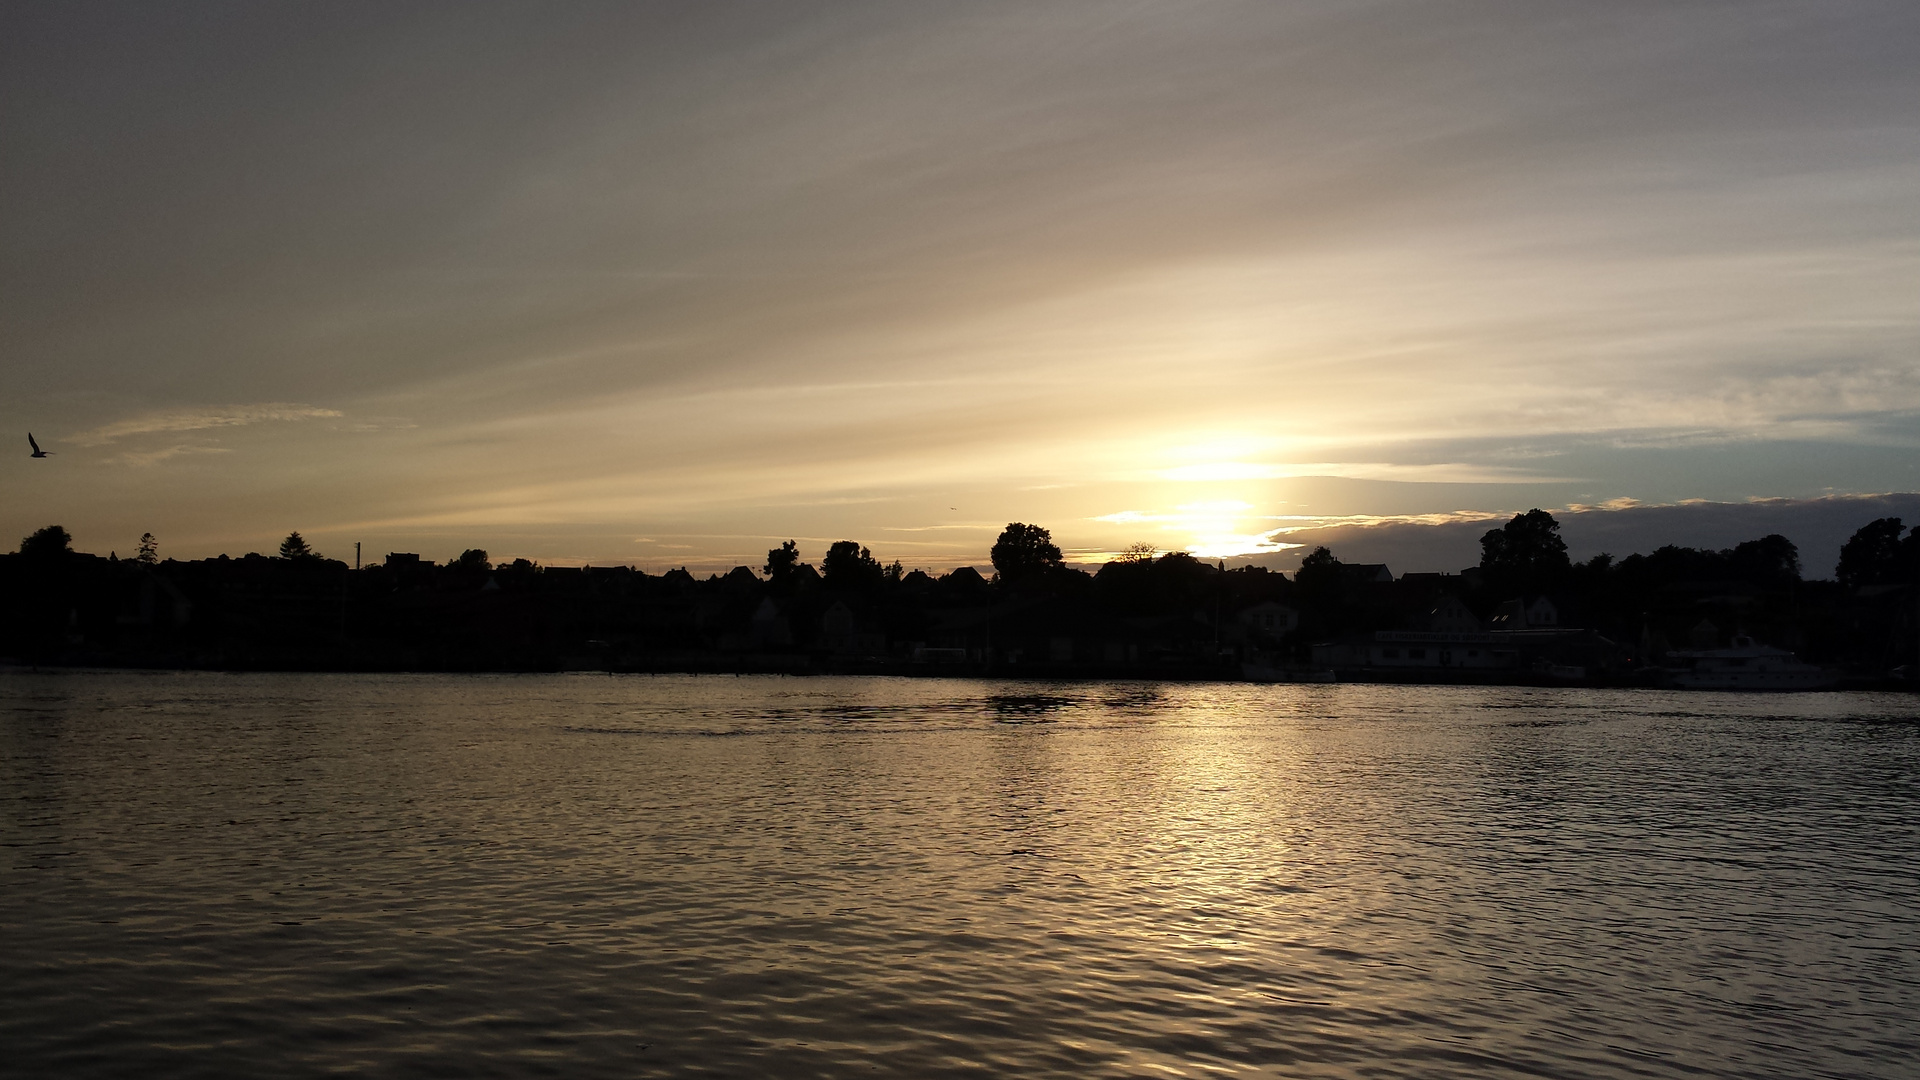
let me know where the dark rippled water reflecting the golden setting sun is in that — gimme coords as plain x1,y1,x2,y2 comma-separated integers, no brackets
0,673,1920,1078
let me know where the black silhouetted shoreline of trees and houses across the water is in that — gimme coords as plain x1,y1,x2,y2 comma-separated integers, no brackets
0,509,1920,682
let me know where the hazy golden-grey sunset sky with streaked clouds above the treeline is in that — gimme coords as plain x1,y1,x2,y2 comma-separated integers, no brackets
0,0,1920,575
